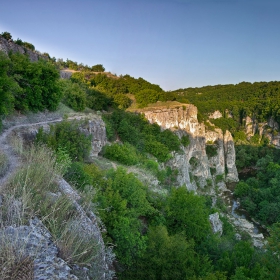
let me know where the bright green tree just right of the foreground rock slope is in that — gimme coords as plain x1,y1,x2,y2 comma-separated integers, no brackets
96,168,153,266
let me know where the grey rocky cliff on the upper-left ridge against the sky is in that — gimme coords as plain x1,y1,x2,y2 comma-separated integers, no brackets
0,35,48,61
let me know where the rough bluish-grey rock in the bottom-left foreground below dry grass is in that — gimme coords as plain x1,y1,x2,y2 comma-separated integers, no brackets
0,217,78,280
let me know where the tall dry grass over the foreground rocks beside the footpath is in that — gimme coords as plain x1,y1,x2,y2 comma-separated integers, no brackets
0,144,98,279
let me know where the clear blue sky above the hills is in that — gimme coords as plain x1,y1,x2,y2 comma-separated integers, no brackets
0,0,280,90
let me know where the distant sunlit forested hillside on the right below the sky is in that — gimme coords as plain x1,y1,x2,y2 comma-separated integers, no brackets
172,81,280,138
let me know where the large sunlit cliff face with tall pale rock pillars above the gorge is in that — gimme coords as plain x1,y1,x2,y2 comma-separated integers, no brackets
143,104,238,190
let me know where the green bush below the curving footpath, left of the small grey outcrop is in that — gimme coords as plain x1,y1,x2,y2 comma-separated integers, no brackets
36,121,91,161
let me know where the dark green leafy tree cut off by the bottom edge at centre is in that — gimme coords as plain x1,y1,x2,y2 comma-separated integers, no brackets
120,226,211,280
